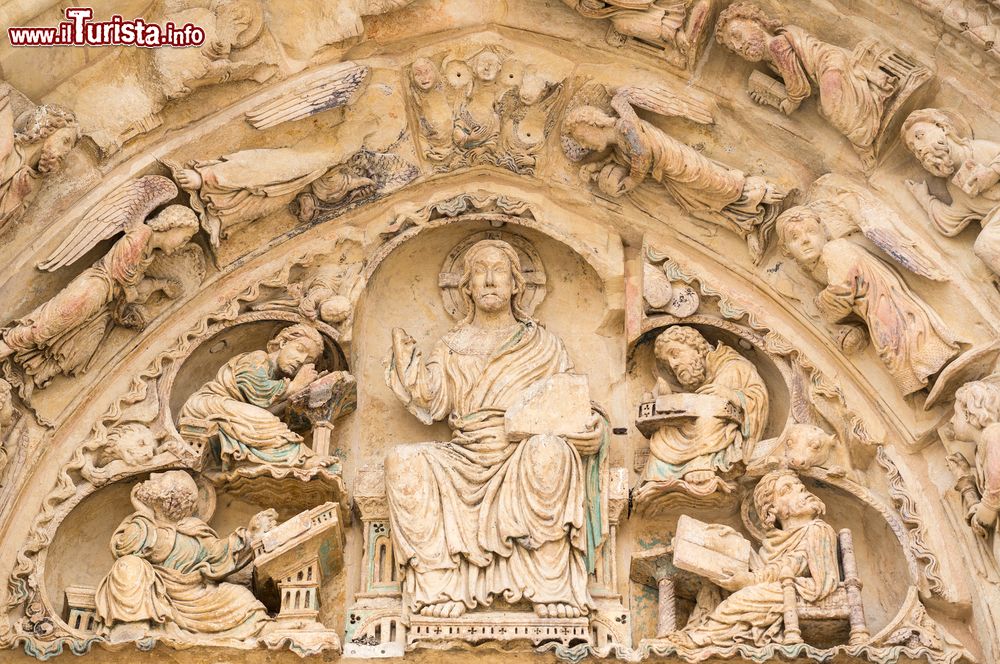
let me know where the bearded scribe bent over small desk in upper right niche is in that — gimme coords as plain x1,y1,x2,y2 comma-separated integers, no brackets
636,326,768,500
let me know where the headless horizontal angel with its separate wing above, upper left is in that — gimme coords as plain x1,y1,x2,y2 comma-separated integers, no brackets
168,63,375,248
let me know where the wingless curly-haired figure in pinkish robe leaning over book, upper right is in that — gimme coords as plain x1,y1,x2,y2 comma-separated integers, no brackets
715,0,930,171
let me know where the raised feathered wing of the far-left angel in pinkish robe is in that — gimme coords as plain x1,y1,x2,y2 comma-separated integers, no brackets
38,175,177,272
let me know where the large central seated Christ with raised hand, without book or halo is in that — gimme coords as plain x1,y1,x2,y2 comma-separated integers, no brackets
385,240,609,618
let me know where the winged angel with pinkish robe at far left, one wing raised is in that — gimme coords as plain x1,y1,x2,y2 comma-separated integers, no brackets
0,175,198,388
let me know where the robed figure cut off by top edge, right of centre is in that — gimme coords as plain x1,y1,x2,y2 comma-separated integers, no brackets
563,0,713,69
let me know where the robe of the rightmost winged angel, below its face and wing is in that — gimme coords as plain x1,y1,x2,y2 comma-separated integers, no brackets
816,238,959,395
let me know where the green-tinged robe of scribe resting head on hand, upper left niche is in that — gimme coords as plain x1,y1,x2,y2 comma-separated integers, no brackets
179,350,312,466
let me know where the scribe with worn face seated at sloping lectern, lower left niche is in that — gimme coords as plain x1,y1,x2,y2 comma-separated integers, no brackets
95,470,276,640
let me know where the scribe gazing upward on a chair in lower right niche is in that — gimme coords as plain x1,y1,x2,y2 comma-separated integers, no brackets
670,470,840,648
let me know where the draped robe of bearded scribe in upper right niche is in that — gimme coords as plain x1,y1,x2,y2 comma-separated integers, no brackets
645,344,768,486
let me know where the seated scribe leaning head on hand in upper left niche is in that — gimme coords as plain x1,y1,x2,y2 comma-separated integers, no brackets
179,325,336,467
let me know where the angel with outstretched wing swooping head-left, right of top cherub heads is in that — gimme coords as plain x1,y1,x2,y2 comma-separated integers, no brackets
563,84,786,262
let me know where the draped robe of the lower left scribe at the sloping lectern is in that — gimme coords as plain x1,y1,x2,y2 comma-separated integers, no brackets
95,512,270,639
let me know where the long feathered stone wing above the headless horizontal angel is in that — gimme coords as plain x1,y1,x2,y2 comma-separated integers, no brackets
246,62,371,129
